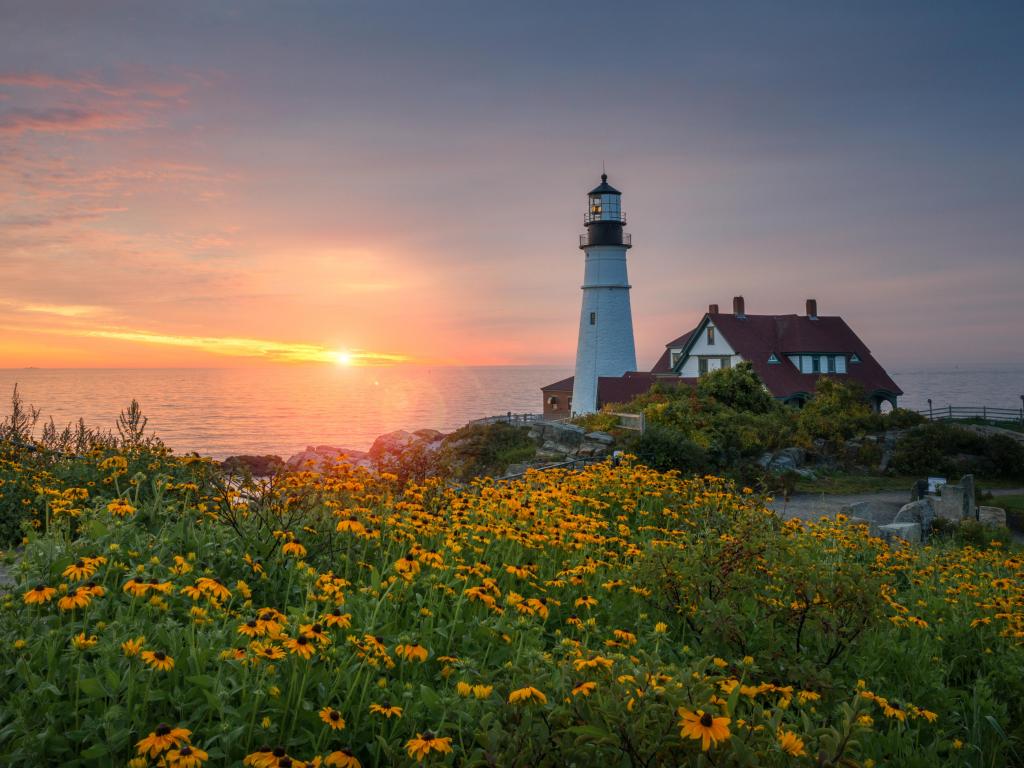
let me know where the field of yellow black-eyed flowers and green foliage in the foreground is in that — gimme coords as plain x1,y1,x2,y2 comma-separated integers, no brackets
0,447,1024,768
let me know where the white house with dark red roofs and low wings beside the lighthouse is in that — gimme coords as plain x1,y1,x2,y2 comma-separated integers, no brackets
542,296,903,419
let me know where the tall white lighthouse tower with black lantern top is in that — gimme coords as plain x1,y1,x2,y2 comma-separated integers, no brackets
572,173,637,414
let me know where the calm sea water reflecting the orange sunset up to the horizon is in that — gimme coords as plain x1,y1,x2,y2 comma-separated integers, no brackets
0,366,1024,459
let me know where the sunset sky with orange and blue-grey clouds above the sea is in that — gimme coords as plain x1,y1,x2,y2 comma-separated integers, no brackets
0,0,1024,370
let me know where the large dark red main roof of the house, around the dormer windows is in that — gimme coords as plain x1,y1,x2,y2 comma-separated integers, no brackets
688,312,903,397
